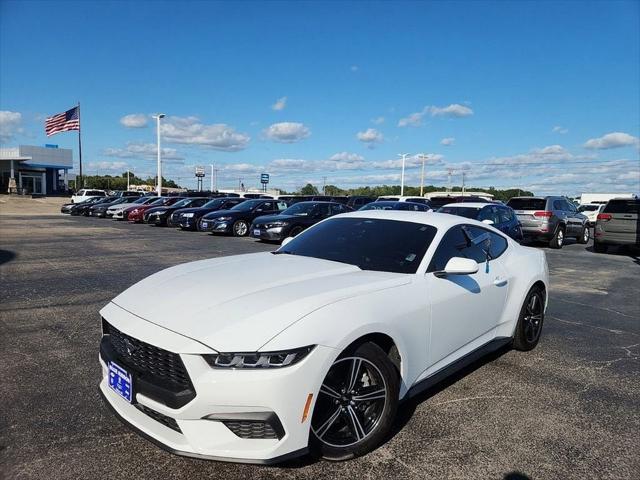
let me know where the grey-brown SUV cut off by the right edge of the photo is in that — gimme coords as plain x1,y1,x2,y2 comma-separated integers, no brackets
593,198,640,253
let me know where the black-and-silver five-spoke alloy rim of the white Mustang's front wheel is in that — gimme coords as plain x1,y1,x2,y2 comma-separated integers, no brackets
311,357,388,447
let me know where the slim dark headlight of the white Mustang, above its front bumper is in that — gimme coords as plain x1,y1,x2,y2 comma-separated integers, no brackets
203,345,315,368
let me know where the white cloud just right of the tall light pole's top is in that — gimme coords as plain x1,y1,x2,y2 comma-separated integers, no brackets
160,117,250,152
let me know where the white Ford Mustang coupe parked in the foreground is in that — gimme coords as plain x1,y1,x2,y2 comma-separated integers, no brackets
100,211,548,463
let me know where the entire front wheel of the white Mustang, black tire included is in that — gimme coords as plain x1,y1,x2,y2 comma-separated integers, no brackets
309,343,400,461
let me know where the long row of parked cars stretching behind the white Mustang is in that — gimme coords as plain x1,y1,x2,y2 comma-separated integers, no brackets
61,190,640,252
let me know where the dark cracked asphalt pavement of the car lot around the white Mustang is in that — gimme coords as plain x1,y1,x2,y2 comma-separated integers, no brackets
0,209,640,480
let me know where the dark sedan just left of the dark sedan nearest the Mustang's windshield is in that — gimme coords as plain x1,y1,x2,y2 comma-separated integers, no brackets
199,199,287,237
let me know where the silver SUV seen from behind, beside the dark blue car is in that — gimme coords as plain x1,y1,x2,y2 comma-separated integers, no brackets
507,197,589,248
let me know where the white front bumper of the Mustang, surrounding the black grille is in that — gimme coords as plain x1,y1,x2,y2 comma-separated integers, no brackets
100,304,337,463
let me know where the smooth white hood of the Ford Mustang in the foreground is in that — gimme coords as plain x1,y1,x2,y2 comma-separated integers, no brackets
107,252,410,352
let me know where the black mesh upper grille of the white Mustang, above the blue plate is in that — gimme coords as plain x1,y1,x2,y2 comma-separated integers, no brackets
103,320,193,390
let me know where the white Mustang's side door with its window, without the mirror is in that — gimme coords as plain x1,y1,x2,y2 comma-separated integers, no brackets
426,225,509,371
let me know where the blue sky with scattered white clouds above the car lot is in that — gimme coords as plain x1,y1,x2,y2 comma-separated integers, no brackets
0,0,640,194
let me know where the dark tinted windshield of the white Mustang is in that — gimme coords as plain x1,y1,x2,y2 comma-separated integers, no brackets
275,217,437,273
